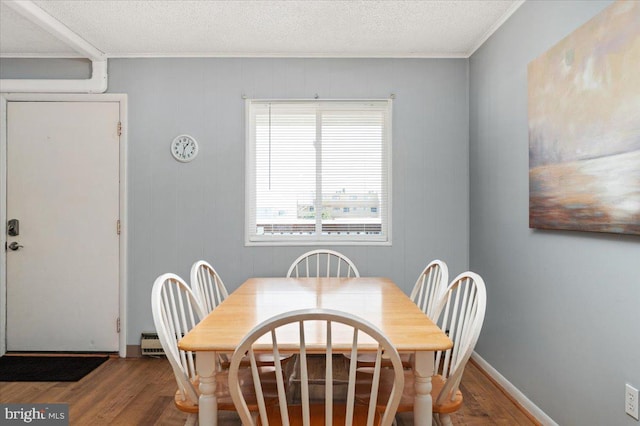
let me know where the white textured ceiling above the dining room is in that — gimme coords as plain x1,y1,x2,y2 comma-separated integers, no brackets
0,0,523,57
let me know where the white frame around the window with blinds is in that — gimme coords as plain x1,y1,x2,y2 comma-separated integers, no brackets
244,99,393,246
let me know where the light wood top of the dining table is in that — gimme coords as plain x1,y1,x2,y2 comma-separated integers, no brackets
179,278,452,352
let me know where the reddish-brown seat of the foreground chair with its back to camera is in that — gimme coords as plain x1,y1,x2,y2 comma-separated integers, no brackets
258,404,380,426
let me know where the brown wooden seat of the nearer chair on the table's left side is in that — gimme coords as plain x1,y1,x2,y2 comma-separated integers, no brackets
174,367,278,413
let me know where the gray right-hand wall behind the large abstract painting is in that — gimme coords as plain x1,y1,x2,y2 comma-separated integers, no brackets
469,1,640,426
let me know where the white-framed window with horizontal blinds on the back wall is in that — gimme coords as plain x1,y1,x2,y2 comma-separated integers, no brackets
246,100,391,245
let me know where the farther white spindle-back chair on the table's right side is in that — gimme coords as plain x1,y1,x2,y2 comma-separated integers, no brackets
409,259,449,319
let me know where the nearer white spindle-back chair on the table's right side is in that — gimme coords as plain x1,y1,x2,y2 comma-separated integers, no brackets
357,272,487,425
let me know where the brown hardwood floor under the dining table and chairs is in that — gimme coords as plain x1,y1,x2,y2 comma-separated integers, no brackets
0,358,536,426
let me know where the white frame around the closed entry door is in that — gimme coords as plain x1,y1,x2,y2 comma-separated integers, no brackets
0,93,128,357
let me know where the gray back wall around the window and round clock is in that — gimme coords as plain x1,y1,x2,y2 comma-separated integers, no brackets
109,59,469,344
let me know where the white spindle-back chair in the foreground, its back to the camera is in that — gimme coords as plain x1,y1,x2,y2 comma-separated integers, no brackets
229,309,404,426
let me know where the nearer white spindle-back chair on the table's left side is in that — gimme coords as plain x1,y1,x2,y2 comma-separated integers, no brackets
151,274,275,425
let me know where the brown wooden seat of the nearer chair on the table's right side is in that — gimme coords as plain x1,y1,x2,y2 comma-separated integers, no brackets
356,368,462,414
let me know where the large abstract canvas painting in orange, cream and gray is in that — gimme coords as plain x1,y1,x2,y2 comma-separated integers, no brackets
528,0,640,235
